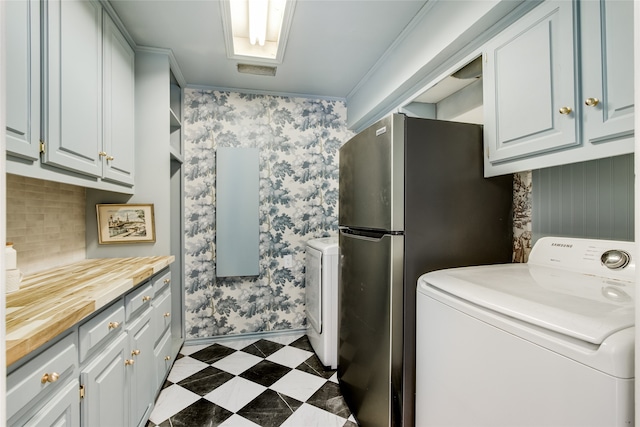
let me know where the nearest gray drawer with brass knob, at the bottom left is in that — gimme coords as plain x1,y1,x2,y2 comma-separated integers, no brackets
6,334,78,419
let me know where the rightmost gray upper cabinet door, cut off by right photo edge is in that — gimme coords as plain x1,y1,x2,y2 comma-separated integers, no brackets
580,0,634,145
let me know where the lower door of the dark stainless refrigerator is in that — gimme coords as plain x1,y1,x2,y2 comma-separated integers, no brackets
338,230,404,427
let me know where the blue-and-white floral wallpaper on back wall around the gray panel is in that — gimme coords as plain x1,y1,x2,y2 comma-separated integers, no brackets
183,89,353,339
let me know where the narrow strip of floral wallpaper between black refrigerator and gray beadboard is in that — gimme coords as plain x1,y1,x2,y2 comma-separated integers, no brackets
513,171,532,262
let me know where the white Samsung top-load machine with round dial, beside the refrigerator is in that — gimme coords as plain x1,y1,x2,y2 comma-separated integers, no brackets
416,238,636,427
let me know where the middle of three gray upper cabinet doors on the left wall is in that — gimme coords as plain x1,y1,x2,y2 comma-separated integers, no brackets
42,0,102,177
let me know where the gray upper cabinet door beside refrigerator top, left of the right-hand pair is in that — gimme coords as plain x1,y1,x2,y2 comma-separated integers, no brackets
483,1,579,164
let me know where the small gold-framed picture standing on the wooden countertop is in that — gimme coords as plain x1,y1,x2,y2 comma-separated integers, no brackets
96,204,156,245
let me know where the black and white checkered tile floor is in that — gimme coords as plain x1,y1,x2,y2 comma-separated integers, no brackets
147,335,356,427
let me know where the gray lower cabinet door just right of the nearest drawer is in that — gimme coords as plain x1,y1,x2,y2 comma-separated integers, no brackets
80,333,131,427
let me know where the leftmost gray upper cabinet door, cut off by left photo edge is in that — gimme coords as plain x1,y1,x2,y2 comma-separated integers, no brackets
5,0,40,161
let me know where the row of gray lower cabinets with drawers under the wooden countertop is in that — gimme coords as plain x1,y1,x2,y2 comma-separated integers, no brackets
6,269,182,427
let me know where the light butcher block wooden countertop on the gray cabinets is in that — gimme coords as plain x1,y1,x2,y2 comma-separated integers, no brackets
6,256,175,366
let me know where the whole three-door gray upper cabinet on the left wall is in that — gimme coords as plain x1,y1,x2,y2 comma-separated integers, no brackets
7,0,135,193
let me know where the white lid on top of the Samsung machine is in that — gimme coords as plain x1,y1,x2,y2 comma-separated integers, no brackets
418,264,635,345
